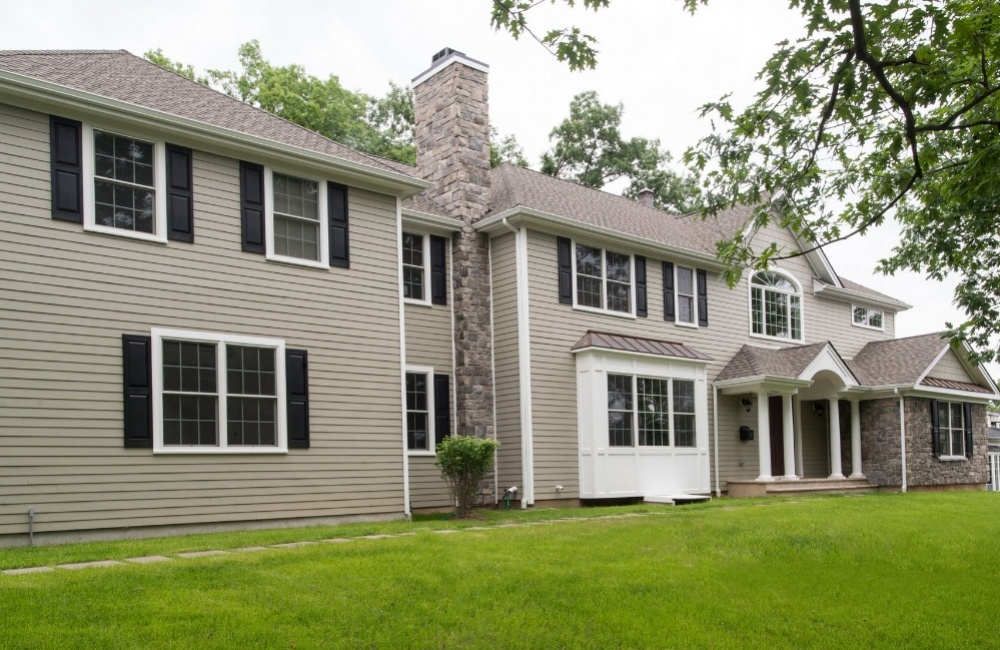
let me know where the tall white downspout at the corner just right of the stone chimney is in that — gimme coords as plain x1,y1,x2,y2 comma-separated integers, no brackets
501,217,535,508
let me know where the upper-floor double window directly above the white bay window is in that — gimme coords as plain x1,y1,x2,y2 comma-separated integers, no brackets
573,244,635,315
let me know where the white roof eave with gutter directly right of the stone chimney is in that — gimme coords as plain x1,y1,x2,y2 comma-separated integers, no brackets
473,205,724,271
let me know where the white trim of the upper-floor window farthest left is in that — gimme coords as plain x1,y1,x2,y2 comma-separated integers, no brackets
81,124,167,244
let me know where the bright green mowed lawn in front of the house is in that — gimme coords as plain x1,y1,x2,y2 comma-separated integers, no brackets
0,493,1000,650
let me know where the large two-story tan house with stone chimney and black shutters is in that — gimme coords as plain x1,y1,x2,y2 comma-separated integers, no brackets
0,50,997,545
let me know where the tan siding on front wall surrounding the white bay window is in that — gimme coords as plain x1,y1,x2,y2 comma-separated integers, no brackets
511,217,893,500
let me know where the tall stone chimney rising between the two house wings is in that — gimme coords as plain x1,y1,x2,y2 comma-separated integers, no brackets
413,48,495,438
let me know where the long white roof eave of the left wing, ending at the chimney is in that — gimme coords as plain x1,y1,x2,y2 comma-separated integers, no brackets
0,70,431,198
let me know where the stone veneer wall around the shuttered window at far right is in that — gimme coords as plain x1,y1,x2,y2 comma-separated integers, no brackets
861,397,989,488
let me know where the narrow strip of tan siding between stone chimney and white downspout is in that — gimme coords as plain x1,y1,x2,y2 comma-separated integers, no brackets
490,234,524,494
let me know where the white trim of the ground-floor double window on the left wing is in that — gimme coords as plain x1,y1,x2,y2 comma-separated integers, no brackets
150,327,288,455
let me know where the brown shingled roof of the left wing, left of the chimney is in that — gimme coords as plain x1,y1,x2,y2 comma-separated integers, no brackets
0,50,416,177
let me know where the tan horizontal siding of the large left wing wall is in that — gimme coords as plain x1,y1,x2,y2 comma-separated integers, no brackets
0,106,403,535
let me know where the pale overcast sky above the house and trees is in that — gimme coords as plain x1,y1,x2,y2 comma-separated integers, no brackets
0,0,998,376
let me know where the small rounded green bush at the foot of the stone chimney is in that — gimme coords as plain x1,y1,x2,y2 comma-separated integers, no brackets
434,436,500,519
